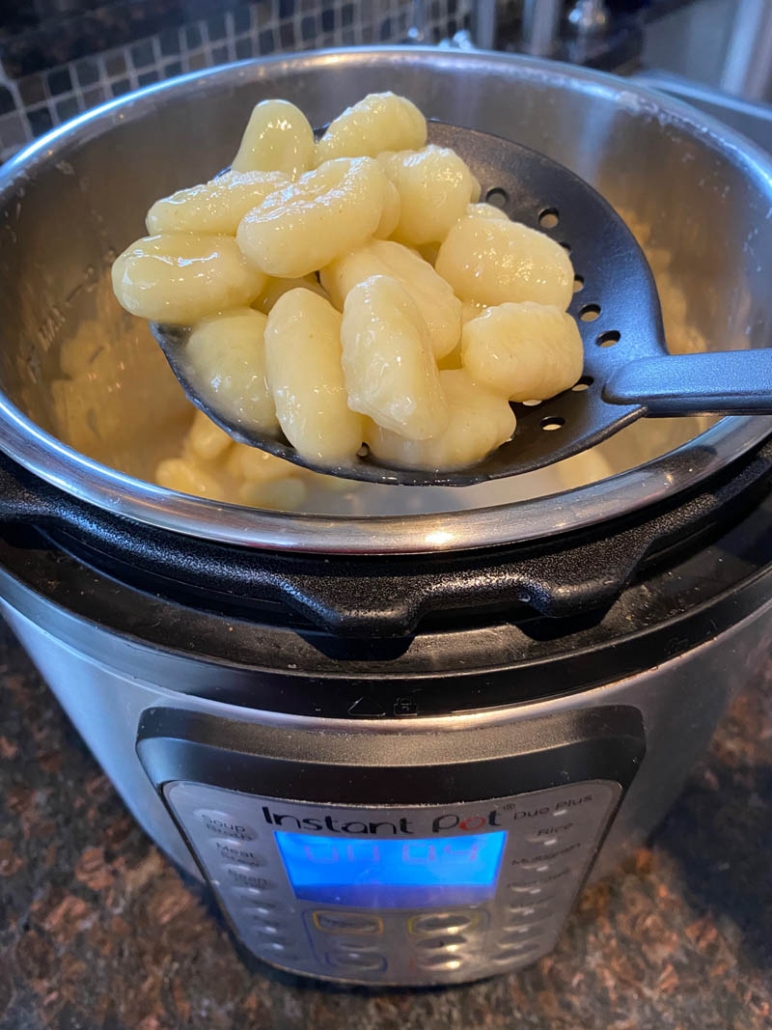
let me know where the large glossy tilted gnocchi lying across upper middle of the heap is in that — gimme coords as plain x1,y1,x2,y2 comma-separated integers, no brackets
236,158,387,279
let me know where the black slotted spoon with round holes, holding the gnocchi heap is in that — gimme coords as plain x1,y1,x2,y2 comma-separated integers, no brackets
152,123,772,486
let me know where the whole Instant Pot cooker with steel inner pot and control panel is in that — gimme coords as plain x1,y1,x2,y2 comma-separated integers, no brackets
0,49,772,985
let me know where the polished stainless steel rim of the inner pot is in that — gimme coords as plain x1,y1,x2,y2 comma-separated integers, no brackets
0,48,772,554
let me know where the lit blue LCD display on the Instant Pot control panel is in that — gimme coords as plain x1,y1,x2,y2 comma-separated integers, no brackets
274,830,506,908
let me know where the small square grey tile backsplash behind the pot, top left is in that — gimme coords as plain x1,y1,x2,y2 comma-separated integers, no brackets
0,0,473,160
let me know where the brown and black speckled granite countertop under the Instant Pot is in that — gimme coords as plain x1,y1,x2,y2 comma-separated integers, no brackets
0,627,772,1030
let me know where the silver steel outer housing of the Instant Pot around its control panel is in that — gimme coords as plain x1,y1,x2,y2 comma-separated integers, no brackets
0,572,771,986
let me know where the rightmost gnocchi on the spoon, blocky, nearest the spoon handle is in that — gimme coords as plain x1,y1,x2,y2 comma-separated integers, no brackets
461,301,584,402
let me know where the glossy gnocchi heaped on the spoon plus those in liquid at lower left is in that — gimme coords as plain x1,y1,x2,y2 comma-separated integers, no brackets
112,93,583,498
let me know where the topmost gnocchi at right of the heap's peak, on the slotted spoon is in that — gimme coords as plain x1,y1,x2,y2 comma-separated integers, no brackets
316,93,426,165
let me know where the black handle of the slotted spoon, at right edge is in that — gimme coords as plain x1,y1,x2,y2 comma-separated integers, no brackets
603,347,772,416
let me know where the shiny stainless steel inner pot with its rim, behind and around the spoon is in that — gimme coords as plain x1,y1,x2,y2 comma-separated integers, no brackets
0,49,772,553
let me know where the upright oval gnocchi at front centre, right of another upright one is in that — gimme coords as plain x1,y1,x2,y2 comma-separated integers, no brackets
341,275,449,440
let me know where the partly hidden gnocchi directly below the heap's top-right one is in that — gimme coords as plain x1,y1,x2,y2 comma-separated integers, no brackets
379,144,478,246
